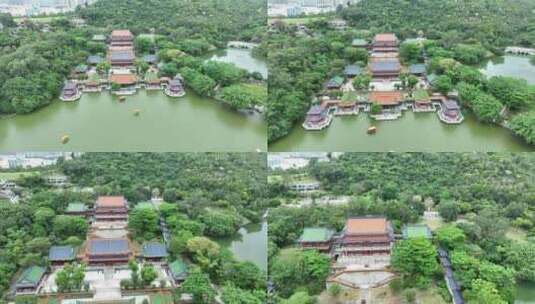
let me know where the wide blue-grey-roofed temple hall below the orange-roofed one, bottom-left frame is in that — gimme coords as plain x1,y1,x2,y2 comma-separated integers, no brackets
84,238,132,265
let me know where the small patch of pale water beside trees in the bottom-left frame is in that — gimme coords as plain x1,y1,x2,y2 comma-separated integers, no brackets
217,221,268,271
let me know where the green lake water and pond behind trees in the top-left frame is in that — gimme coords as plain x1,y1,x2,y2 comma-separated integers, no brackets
0,50,267,152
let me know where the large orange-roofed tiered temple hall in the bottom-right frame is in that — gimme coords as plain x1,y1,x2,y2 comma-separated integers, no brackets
335,217,394,257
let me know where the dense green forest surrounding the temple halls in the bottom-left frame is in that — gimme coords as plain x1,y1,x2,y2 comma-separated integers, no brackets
0,153,268,304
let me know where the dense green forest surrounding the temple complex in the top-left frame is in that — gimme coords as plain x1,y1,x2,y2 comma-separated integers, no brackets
0,0,267,114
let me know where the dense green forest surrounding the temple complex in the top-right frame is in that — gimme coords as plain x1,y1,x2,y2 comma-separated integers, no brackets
268,0,535,143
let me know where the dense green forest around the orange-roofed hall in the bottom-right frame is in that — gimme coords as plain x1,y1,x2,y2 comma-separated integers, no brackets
269,153,535,303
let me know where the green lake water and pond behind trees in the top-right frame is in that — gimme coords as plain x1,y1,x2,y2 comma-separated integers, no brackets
269,56,535,152
